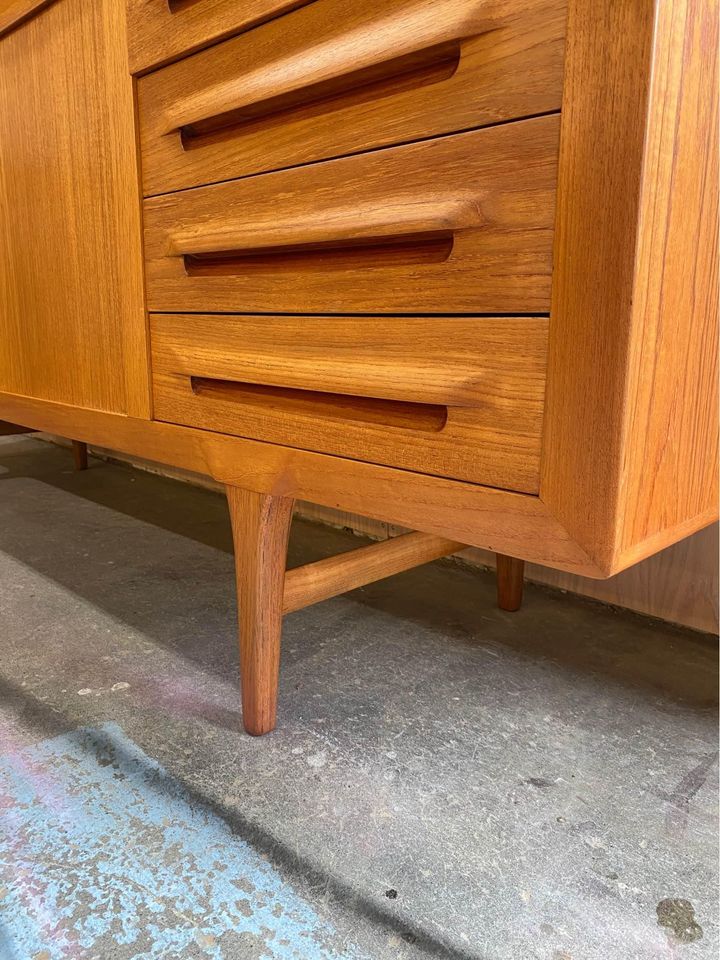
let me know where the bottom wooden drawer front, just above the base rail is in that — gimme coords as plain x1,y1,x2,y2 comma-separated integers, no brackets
150,314,548,493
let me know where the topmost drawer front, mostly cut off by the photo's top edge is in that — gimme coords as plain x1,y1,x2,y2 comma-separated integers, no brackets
127,0,309,73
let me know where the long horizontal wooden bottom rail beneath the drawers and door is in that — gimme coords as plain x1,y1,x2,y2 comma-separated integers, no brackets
0,393,609,577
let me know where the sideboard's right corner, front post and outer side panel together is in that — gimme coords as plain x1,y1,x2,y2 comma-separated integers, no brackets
540,0,717,570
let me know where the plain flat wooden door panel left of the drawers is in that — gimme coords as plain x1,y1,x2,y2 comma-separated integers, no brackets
0,0,149,416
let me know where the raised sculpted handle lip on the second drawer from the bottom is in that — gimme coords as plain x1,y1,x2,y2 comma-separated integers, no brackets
167,196,483,257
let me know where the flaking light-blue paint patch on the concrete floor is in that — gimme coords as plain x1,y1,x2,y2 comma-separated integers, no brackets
0,724,360,960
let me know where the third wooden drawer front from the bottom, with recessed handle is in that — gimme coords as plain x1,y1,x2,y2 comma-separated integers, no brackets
138,0,566,196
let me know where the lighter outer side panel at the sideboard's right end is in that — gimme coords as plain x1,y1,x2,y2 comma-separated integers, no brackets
620,0,718,560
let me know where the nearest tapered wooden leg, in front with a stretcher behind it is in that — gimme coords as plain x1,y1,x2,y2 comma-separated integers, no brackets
226,486,294,737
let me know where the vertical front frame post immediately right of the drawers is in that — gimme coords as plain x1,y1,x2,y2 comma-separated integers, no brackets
540,0,654,572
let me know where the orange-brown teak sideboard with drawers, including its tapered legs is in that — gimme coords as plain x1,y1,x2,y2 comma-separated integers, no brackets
0,0,718,734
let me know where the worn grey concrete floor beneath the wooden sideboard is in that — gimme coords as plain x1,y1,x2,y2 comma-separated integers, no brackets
0,438,718,960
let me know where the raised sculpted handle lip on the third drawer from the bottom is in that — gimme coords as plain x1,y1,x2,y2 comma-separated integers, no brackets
161,0,507,134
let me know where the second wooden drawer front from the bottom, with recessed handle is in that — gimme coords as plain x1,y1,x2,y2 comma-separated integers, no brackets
145,116,558,313
